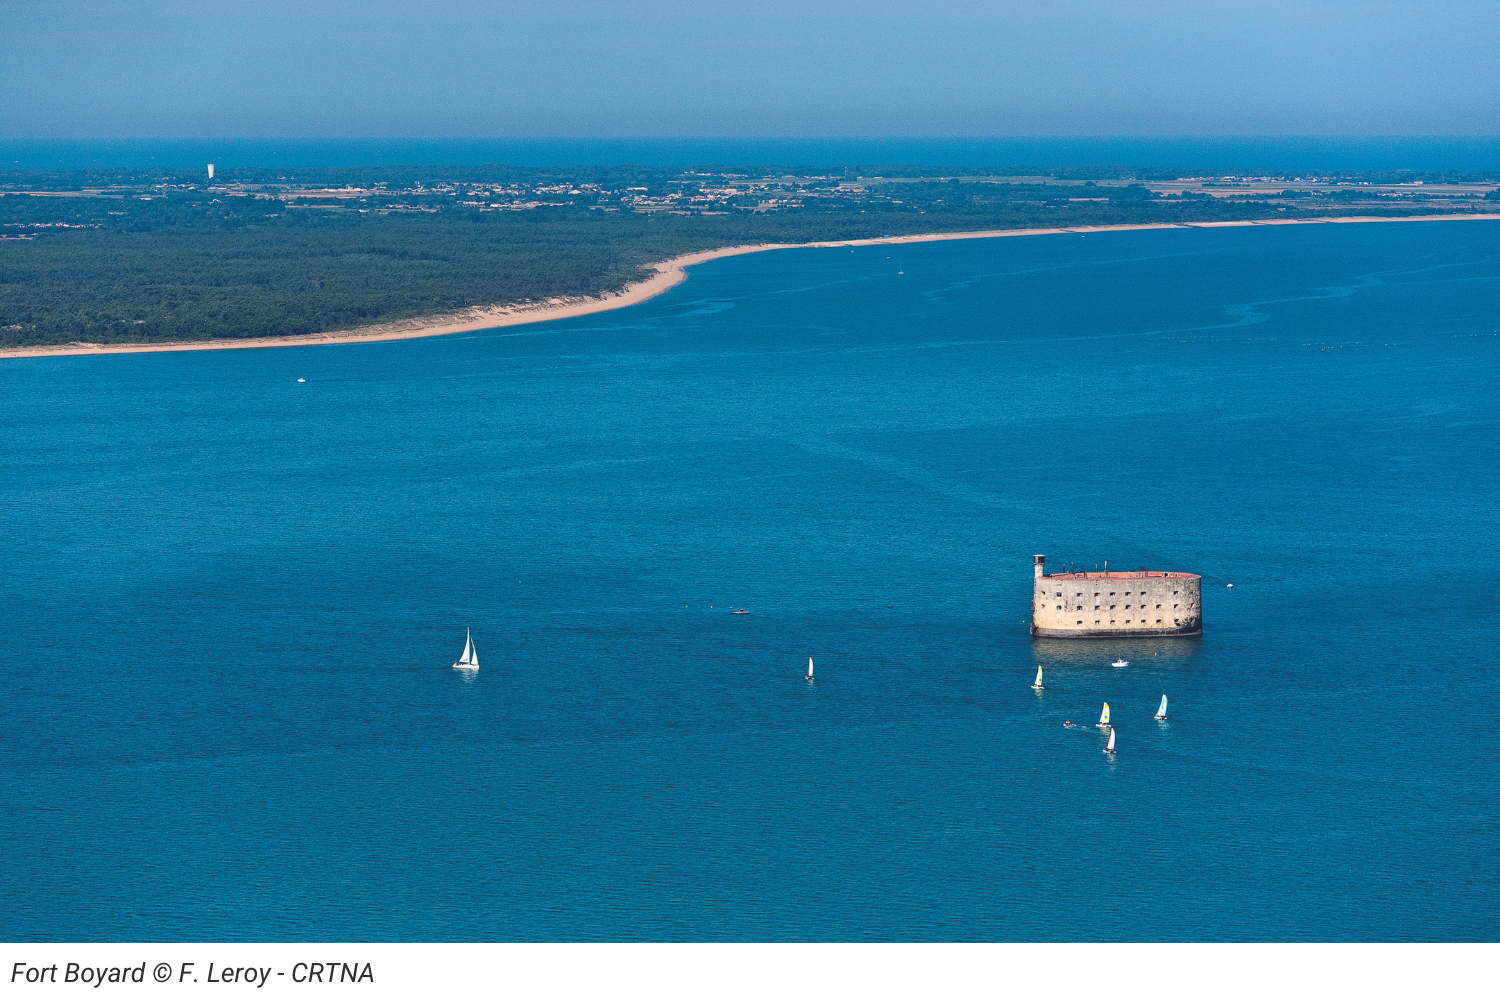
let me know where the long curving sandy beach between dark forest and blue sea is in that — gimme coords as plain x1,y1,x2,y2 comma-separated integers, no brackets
0,213,1500,358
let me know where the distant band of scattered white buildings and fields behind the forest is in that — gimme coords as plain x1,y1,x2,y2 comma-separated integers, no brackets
0,168,1500,237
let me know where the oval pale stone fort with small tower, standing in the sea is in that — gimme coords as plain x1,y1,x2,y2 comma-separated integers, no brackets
1032,556,1203,639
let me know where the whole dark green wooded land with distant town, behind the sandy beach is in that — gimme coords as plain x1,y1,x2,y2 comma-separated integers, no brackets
0,166,1500,346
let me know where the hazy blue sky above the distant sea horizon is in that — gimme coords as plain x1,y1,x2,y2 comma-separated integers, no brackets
0,0,1500,139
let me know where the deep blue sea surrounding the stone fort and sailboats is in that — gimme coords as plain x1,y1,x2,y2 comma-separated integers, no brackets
0,222,1500,942
